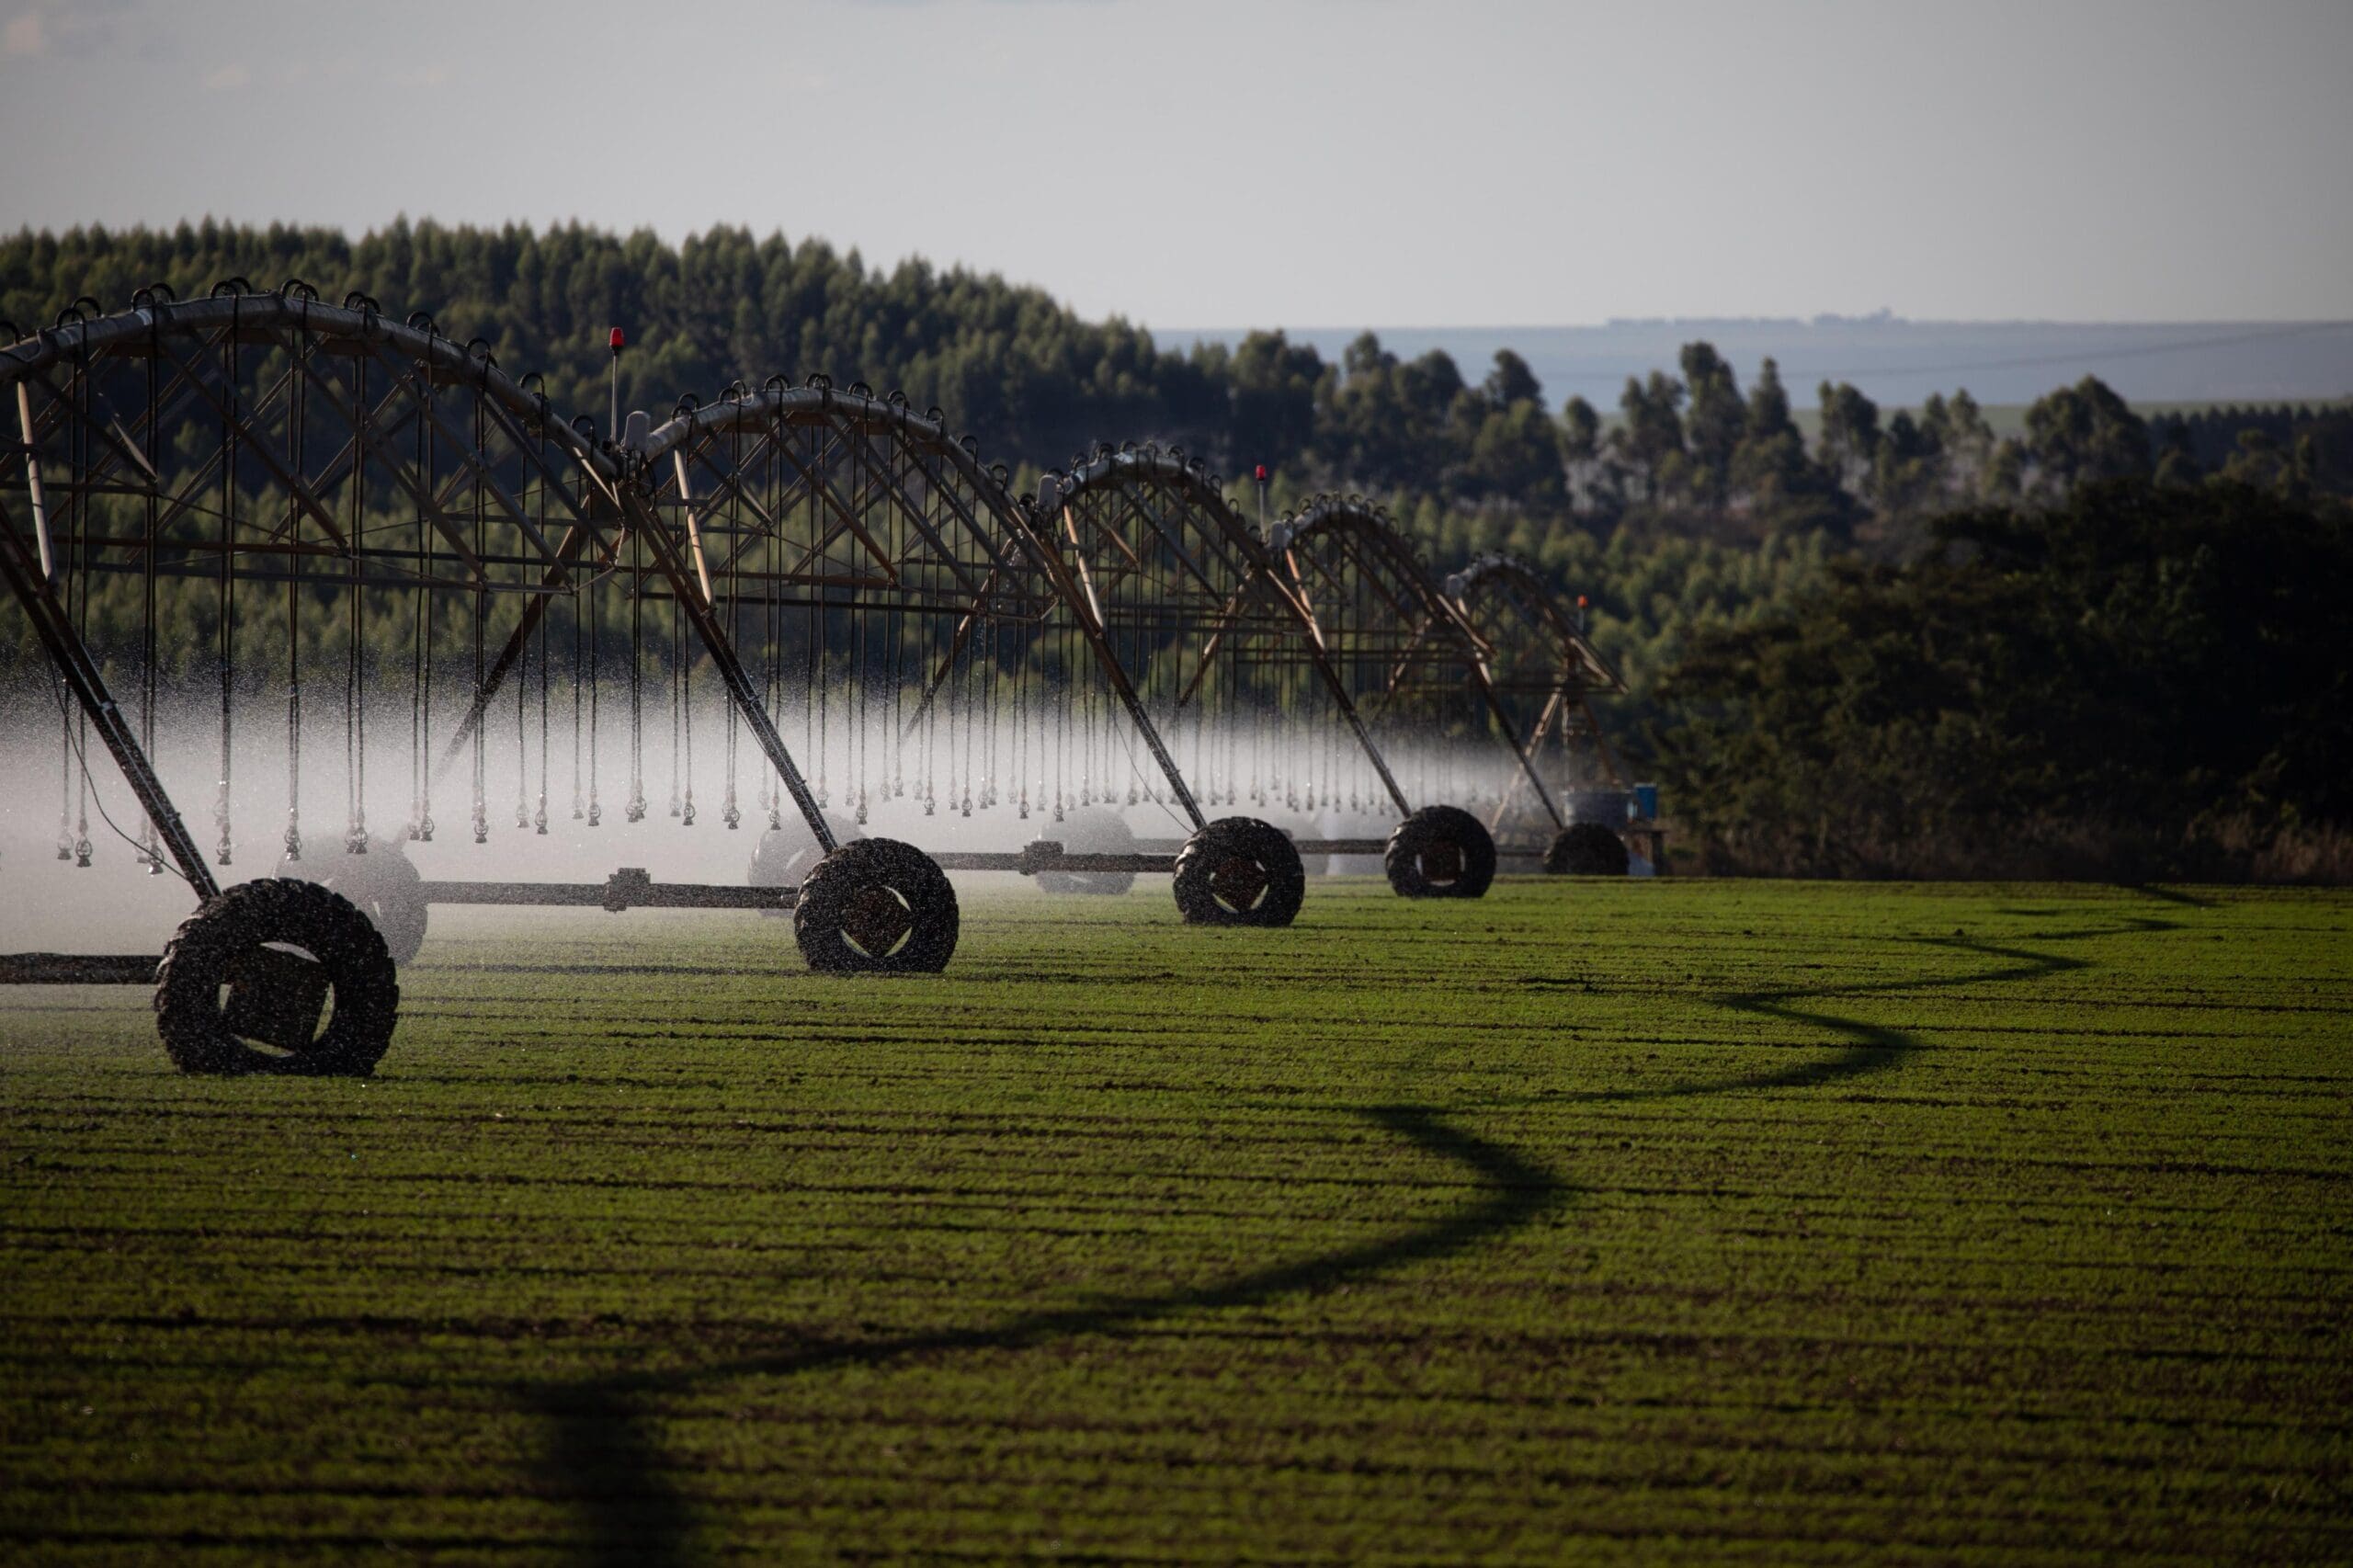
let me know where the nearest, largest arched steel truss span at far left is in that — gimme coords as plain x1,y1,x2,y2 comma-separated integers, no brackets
0,280,629,900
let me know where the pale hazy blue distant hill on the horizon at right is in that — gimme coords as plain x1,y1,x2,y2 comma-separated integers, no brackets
1153,315,2353,410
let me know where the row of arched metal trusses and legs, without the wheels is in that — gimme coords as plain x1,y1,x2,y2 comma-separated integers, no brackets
0,280,1614,941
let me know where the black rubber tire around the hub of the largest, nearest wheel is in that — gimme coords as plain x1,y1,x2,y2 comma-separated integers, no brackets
155,878,400,1078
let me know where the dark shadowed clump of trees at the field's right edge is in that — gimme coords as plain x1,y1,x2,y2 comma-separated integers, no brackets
1650,478,2353,883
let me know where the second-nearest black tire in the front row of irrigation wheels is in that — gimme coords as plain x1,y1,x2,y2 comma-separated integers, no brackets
793,838,958,974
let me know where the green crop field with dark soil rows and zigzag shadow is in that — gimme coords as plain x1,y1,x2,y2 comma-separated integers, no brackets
0,881,2353,1563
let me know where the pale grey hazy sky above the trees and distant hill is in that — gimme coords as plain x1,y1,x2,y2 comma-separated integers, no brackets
0,0,2353,330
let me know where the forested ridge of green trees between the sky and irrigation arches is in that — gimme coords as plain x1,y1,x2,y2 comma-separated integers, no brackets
14,219,2353,531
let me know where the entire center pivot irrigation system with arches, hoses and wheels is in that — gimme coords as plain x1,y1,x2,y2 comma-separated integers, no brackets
0,280,1617,1074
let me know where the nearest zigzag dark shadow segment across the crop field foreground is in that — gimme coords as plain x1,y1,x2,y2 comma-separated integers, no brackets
529,1104,1567,1565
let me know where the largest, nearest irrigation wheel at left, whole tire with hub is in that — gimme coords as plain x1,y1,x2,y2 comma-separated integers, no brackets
155,876,400,1078
